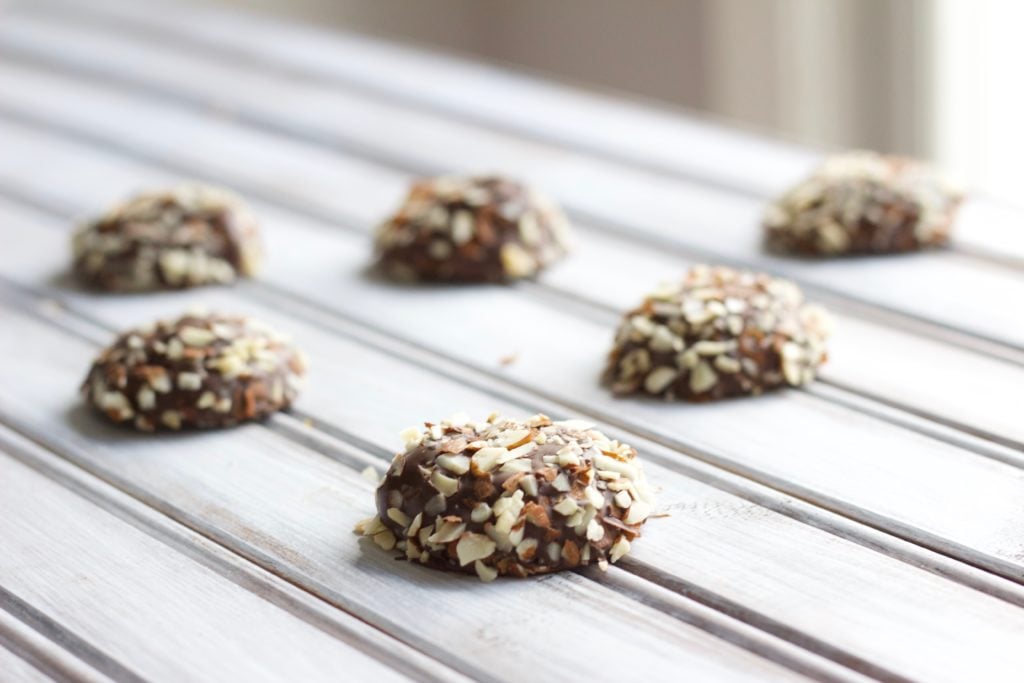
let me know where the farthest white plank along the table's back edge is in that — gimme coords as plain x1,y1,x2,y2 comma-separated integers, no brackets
34,0,1024,267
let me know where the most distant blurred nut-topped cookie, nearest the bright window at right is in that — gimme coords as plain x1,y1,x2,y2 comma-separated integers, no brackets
764,152,963,256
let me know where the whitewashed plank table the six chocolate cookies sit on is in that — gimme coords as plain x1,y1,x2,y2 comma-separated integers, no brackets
0,0,1024,682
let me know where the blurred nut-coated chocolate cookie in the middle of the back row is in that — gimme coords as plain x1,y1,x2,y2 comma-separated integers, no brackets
376,176,569,283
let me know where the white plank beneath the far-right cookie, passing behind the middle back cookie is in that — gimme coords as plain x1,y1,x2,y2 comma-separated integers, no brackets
3,20,1024,351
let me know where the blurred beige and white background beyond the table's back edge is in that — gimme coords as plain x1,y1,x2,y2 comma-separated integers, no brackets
211,0,1024,202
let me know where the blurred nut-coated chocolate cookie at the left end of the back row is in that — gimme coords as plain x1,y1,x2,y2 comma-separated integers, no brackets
72,183,262,292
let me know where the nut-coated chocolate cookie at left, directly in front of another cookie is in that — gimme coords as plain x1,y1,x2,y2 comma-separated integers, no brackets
82,313,306,431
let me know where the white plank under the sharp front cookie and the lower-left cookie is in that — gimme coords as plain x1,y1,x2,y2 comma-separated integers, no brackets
0,311,831,680
